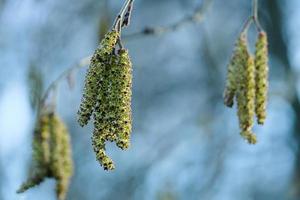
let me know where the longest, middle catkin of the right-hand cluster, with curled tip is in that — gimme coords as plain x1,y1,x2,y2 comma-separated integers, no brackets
236,34,256,144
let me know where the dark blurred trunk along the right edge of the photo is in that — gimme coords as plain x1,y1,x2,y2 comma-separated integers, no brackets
262,0,300,199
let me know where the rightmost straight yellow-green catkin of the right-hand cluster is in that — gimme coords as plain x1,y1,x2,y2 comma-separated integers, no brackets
255,31,269,124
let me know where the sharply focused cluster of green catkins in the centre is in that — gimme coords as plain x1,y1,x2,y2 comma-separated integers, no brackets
78,30,132,170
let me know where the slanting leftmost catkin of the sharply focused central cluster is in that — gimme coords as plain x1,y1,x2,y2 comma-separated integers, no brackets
78,30,119,126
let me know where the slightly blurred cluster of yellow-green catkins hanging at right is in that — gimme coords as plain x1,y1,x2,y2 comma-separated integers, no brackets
224,31,269,144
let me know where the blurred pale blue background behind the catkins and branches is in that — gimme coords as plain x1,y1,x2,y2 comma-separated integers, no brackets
0,0,300,200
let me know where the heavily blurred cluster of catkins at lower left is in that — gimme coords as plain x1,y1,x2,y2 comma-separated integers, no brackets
17,112,73,200
